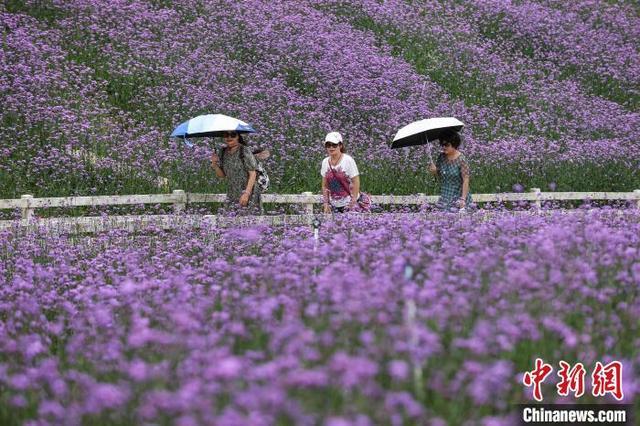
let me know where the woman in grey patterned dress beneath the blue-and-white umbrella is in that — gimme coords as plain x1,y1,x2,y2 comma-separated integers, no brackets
211,131,260,212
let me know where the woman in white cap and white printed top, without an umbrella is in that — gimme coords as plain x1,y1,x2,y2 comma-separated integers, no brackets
320,132,360,213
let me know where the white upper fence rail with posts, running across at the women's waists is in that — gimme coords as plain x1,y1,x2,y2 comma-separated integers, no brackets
0,188,640,220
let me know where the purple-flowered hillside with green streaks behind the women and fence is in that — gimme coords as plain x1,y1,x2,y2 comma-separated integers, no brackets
0,0,640,197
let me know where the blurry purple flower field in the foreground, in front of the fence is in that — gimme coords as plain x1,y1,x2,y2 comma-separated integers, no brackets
0,209,640,425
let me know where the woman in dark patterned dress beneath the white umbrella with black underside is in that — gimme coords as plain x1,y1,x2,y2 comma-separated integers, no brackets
429,130,471,210
